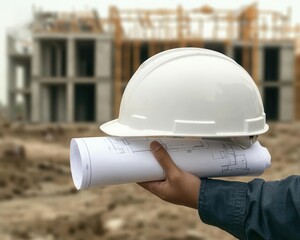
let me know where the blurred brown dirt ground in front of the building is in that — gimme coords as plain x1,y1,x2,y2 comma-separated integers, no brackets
0,121,300,240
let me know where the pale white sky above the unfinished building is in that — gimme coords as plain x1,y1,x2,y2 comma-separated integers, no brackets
0,0,300,105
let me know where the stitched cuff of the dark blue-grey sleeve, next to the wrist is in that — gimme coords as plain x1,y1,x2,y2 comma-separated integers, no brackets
198,179,248,239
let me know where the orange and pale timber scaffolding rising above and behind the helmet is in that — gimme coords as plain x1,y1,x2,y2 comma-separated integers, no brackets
109,4,300,115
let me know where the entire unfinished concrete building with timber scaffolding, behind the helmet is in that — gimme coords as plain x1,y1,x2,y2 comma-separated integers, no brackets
9,5,300,122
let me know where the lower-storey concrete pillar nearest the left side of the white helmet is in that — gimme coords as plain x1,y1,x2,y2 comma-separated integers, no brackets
96,80,113,123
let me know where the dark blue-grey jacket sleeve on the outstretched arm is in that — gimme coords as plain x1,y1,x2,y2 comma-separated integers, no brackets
198,176,300,239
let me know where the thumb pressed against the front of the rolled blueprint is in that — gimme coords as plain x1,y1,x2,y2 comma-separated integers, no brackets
150,141,180,177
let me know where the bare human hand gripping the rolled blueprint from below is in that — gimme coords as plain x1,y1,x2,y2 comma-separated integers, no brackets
138,141,200,209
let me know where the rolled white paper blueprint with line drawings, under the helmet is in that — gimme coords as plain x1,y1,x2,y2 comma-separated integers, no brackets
70,137,271,189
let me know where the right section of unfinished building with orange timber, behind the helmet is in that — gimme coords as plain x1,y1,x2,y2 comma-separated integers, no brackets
110,5,300,121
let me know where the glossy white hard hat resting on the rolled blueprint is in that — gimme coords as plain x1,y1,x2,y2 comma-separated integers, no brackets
100,48,268,137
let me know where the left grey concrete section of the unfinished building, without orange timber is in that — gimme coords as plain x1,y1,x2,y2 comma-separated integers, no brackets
8,11,114,122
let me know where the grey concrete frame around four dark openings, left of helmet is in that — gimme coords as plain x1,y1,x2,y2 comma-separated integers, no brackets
31,34,114,123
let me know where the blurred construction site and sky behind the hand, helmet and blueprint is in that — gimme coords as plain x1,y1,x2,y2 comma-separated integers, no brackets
0,0,300,240
